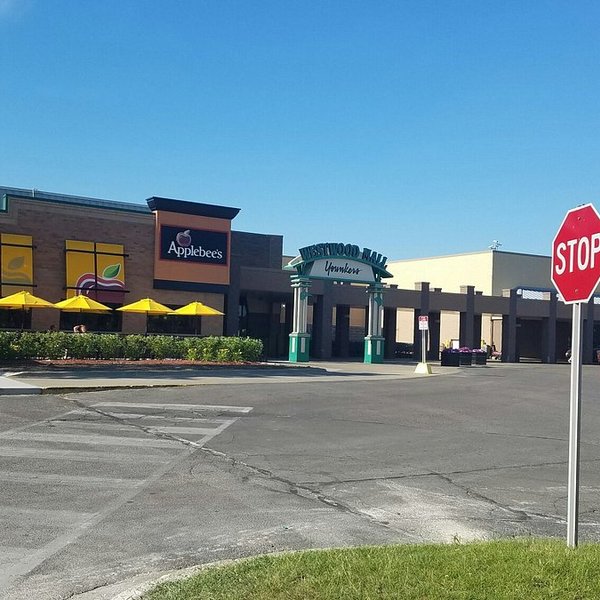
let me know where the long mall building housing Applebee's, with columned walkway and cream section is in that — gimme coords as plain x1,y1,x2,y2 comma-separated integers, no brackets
0,187,600,362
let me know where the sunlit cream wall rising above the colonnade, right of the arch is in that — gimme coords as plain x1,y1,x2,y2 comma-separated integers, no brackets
386,250,493,295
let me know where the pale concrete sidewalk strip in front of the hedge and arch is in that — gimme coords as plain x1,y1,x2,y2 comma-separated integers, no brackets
0,361,457,396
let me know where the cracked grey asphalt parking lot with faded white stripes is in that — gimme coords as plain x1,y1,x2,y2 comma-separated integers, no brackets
0,363,600,600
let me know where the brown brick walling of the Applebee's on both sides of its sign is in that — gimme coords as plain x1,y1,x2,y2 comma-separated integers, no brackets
0,198,283,335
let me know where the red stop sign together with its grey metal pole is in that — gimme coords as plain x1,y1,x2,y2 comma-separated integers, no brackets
551,204,600,548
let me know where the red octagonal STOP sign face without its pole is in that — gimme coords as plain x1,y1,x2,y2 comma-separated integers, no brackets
550,204,600,304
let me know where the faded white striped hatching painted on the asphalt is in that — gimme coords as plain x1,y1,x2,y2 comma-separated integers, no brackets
0,402,252,591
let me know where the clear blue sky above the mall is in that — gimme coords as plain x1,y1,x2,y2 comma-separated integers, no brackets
0,0,600,259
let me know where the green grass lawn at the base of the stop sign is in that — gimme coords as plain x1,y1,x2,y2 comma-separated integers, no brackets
143,539,600,600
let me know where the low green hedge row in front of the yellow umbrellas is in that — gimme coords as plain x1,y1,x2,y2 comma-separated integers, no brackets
0,331,263,362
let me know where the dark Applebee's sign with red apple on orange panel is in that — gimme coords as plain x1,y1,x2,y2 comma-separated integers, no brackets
160,225,228,265
